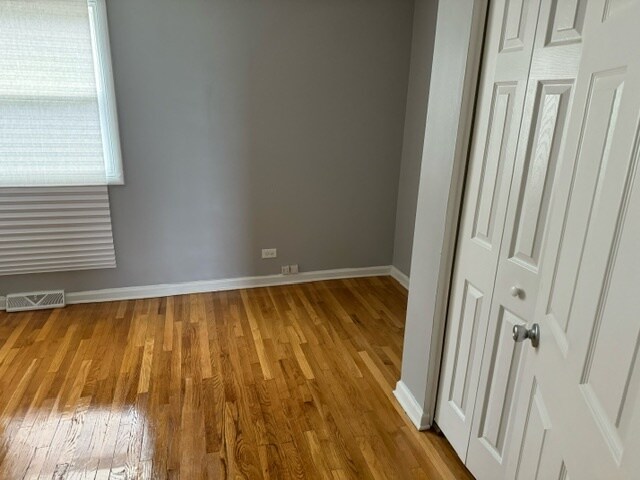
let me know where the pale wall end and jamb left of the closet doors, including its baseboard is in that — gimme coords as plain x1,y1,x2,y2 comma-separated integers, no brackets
394,0,489,430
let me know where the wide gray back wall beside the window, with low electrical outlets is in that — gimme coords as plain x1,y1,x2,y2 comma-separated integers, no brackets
0,0,414,294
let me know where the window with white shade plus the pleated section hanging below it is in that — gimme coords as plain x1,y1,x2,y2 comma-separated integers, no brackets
0,0,122,275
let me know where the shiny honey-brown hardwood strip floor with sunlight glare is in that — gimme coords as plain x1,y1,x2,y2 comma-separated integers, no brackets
0,277,471,480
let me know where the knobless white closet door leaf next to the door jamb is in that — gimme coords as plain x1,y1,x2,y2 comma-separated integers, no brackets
436,0,539,459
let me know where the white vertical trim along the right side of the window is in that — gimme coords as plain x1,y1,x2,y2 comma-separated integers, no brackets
87,0,124,185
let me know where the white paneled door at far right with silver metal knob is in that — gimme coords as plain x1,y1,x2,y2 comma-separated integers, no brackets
507,0,640,480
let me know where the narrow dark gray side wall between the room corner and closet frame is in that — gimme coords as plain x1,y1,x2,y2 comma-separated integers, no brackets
393,0,438,275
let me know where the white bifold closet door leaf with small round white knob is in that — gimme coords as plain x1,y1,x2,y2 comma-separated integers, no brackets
466,0,587,479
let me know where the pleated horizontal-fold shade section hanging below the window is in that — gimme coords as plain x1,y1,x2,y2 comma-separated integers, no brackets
0,186,116,275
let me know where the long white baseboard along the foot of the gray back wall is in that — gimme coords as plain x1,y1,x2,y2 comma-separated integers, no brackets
0,266,395,310
